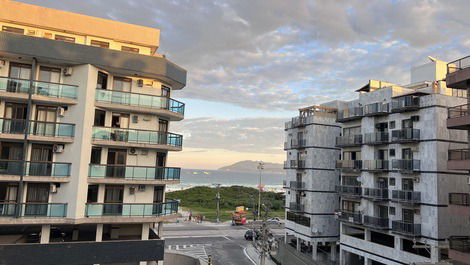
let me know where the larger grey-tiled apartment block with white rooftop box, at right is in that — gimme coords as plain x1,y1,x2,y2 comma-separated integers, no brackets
336,58,470,265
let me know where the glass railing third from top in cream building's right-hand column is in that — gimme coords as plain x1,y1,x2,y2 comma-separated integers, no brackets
89,165,181,180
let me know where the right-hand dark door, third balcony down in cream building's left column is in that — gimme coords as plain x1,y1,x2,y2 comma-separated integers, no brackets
29,144,53,176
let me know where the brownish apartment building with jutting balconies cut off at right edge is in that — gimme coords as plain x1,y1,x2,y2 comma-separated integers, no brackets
446,56,470,264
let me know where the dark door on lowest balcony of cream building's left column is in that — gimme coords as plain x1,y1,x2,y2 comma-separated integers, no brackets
24,183,50,216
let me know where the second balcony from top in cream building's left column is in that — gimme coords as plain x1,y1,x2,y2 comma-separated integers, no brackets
0,118,75,143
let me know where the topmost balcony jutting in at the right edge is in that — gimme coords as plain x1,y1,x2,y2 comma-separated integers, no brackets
446,56,470,89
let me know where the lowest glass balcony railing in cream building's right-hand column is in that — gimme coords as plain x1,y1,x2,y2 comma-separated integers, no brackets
85,201,178,217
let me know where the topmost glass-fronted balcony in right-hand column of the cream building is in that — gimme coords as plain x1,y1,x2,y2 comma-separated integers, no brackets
95,89,185,121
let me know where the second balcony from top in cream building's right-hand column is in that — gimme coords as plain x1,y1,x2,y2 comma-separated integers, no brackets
92,126,183,151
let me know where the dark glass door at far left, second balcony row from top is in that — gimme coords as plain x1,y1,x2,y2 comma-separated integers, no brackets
2,103,28,133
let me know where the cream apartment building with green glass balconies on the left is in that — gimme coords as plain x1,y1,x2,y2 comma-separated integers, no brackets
0,0,186,264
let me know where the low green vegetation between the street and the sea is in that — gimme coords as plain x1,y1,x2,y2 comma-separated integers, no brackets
166,186,284,221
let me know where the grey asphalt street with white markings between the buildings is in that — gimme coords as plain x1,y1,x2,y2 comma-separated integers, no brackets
164,222,284,265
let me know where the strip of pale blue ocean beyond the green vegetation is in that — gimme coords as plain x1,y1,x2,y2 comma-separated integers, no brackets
167,169,285,192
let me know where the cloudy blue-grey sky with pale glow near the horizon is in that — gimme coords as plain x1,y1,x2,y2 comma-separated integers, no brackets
21,0,470,169
